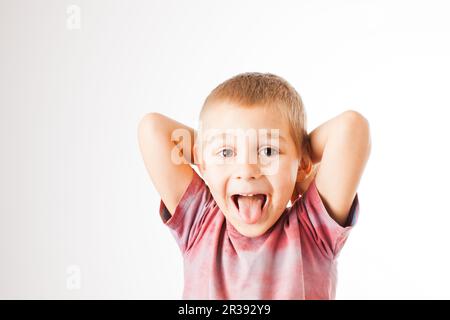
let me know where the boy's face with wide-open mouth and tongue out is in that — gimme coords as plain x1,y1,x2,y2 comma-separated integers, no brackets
195,102,300,237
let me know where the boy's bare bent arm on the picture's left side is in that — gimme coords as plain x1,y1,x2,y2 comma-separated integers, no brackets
138,113,195,215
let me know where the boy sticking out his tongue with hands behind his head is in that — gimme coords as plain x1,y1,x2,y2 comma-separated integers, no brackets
138,72,371,299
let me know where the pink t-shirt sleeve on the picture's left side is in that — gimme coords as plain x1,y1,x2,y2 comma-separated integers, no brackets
159,170,214,253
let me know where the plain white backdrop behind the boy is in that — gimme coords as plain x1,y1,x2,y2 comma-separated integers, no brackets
0,0,450,299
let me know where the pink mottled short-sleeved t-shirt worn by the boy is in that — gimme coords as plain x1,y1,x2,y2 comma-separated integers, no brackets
159,171,359,299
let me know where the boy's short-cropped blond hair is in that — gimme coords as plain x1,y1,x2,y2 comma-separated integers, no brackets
200,72,310,157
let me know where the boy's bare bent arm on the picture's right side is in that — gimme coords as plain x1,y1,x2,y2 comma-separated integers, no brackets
309,110,371,226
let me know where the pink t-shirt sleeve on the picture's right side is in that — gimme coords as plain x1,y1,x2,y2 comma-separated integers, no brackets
298,179,359,259
